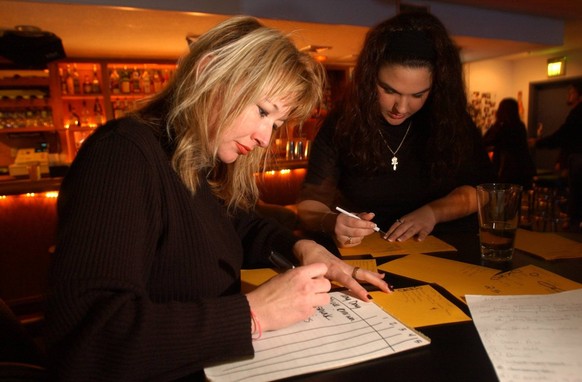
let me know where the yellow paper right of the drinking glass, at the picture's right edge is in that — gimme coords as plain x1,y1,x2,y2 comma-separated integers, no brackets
515,229,582,260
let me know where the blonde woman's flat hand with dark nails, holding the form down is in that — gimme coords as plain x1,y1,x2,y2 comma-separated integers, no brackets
293,240,390,301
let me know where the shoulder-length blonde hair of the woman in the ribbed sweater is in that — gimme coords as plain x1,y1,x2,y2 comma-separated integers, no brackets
138,16,325,210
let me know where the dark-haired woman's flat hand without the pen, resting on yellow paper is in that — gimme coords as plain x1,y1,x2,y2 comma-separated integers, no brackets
384,205,437,241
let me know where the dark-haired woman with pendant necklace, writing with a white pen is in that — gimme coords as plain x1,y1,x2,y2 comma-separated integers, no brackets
297,12,494,247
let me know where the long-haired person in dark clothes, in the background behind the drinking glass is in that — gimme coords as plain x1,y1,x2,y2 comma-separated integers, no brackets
483,98,536,190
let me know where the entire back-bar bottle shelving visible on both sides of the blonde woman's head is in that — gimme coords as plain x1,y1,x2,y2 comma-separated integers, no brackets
0,59,349,173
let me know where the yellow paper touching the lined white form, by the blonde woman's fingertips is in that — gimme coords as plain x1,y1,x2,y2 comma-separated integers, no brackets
370,285,471,328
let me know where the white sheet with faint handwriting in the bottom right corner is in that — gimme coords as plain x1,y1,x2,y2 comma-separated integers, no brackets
466,289,582,382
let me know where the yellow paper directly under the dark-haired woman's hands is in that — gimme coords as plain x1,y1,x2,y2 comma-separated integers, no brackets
339,234,456,257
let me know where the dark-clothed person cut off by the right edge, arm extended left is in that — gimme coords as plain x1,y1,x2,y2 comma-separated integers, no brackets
530,80,582,231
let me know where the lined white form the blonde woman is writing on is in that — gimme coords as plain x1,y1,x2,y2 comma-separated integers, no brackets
205,292,430,381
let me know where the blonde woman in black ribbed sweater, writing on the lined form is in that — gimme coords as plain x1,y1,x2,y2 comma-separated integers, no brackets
46,16,388,381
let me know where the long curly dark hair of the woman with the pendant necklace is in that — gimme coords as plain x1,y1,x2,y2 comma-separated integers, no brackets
335,12,476,180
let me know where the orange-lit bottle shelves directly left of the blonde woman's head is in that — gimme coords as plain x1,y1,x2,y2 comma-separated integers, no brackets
50,60,176,161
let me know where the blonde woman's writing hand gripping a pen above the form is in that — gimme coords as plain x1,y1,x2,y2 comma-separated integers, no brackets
246,263,331,331
